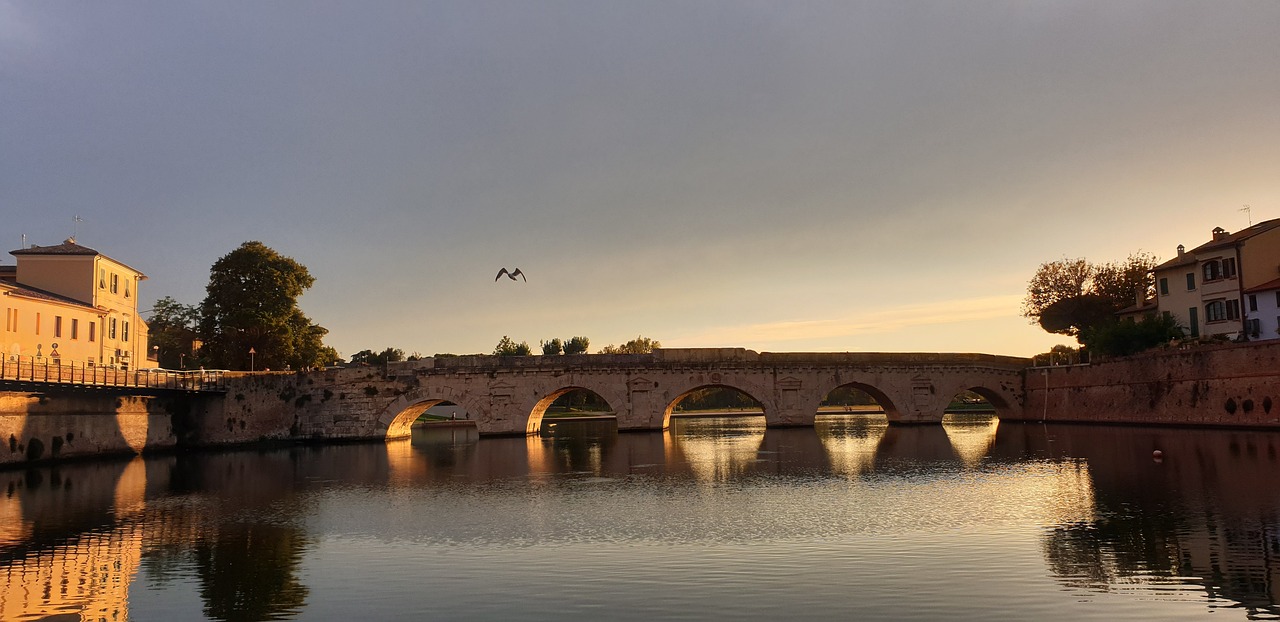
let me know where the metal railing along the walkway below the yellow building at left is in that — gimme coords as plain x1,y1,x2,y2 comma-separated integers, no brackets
0,355,227,390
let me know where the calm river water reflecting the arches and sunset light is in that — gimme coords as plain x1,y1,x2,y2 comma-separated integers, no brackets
0,416,1280,621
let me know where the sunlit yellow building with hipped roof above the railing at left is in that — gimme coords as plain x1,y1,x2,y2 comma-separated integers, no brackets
0,239,148,369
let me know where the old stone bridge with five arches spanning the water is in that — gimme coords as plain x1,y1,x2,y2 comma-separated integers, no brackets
272,348,1030,439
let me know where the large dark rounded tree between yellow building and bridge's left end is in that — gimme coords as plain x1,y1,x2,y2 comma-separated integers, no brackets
198,242,332,369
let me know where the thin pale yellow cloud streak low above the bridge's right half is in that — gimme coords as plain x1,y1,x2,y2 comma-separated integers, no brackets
671,294,1021,347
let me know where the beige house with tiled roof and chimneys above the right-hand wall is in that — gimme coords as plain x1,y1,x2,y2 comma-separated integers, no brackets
1155,219,1280,339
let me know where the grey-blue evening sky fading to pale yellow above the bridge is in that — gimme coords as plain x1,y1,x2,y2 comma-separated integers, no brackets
0,0,1280,357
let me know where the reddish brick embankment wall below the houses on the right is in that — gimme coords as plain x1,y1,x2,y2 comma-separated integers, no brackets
1005,342,1280,427
